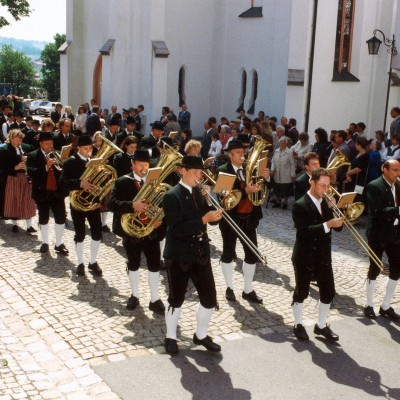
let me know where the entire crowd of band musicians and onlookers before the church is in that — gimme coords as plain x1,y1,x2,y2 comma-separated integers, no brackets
0,99,400,354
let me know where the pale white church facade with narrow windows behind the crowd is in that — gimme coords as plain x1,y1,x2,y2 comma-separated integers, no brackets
59,0,400,137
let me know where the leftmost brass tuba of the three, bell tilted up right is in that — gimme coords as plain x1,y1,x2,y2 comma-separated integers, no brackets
70,137,122,211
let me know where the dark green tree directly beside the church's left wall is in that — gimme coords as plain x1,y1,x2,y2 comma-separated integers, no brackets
40,33,66,101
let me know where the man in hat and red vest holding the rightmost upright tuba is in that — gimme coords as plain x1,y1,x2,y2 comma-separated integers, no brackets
218,139,269,304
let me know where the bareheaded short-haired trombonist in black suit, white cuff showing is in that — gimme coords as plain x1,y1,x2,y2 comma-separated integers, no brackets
292,168,343,342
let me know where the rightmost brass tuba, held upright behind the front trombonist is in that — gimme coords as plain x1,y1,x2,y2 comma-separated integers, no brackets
246,136,271,206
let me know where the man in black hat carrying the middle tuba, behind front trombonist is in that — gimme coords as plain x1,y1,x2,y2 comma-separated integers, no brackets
108,150,165,314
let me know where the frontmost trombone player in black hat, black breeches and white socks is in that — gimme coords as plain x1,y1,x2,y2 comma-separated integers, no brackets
163,156,222,355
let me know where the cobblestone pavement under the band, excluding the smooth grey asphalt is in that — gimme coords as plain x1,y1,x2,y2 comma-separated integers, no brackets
0,198,400,400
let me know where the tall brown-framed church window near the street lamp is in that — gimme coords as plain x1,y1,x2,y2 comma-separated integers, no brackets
334,0,356,74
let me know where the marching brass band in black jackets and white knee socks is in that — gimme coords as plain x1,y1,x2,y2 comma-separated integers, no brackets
0,107,400,355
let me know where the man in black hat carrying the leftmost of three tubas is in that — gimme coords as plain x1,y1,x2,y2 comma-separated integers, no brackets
59,135,103,276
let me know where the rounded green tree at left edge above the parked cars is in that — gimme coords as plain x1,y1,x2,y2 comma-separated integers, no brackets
0,44,35,96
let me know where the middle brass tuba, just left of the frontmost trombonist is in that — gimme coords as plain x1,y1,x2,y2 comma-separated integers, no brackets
121,143,182,238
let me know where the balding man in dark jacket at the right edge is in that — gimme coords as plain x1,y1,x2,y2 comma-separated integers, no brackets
364,159,400,321
